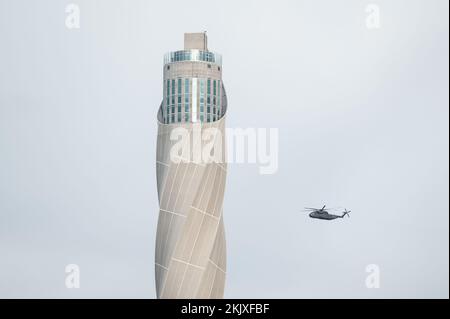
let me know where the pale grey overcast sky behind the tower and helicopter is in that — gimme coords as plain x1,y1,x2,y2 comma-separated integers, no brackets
0,0,449,298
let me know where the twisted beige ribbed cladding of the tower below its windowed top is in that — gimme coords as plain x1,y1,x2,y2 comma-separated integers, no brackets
155,91,227,299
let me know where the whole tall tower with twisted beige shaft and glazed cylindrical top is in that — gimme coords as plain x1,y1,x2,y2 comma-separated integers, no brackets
155,33,227,299
